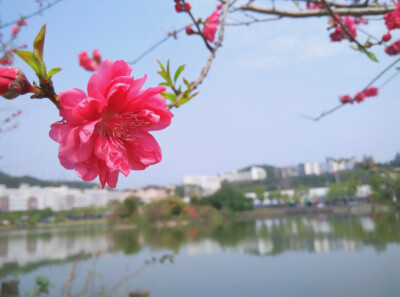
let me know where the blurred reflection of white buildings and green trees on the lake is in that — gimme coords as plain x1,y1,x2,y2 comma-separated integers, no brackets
0,214,400,277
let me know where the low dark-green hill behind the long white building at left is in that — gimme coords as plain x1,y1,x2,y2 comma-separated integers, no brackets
0,171,96,189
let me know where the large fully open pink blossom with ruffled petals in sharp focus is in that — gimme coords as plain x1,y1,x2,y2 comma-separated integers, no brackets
50,60,173,188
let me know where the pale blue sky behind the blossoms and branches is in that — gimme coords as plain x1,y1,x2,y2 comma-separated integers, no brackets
0,0,400,189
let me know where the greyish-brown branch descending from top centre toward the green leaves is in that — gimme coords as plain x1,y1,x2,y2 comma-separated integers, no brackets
168,0,229,108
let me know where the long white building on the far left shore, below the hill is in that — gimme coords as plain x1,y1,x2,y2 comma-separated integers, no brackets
0,184,124,211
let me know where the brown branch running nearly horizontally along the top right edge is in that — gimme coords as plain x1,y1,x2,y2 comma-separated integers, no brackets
236,4,396,18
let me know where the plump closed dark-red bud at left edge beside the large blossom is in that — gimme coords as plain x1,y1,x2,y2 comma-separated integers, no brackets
0,67,35,99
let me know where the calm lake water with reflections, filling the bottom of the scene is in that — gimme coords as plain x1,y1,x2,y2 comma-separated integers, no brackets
0,214,400,297
